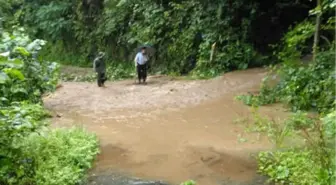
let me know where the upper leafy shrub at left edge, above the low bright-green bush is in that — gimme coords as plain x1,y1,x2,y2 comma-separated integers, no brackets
0,29,58,102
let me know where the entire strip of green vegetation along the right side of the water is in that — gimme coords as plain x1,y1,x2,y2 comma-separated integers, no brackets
238,1,336,185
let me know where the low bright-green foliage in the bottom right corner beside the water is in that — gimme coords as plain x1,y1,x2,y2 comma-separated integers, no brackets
251,111,336,185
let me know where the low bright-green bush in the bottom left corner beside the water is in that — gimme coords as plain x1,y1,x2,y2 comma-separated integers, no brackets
0,103,98,185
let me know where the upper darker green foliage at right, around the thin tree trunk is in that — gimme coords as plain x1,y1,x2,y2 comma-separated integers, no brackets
237,11,336,112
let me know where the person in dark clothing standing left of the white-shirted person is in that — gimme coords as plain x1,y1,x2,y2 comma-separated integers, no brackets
93,52,106,87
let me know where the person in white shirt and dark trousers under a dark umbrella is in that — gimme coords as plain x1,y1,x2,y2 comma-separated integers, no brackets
134,47,148,84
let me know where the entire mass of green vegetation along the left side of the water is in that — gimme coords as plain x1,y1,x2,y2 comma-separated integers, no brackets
0,28,98,185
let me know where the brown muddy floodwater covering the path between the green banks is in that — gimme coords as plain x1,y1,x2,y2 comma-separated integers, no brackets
45,69,284,185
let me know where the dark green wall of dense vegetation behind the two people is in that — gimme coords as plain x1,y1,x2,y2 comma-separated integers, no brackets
0,0,315,77
